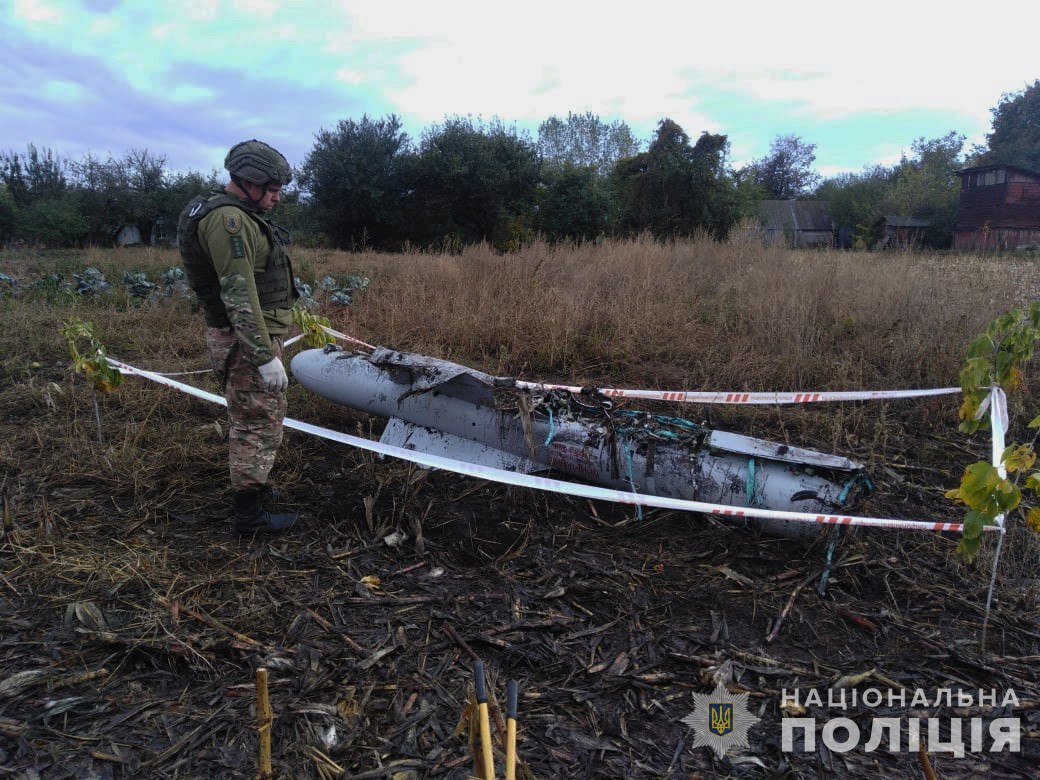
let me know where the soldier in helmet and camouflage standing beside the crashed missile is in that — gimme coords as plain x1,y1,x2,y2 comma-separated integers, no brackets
177,138,300,534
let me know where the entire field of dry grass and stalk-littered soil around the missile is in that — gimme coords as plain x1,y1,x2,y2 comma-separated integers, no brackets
0,240,1040,778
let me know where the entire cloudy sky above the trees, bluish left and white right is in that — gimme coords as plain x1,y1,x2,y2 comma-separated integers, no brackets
0,0,1040,182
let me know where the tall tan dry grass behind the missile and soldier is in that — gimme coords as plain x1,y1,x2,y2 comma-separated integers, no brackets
0,238,1038,416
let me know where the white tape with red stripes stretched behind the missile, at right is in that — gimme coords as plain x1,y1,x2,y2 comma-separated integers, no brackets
517,382,961,405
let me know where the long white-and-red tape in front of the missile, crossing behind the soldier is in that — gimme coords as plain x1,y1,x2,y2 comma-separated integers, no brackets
108,358,997,531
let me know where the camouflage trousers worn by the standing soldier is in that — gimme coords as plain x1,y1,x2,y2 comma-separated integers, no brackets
206,328,287,490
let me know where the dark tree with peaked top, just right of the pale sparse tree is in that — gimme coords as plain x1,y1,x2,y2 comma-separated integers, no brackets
613,119,737,239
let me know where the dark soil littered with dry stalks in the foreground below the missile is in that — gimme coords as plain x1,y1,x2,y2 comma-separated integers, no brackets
0,372,1040,778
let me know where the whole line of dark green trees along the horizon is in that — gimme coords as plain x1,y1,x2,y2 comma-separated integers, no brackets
6,80,1040,251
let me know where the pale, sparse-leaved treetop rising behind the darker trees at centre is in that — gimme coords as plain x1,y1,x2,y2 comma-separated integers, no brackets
538,111,640,175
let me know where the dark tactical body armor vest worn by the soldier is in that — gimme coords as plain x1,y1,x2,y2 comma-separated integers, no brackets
177,190,300,328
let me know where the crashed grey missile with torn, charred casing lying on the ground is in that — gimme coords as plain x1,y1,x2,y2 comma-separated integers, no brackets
291,346,869,537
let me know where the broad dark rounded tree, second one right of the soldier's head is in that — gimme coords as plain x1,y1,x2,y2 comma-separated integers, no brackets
410,116,540,248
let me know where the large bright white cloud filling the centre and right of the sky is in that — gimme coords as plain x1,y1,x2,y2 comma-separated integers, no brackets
337,0,1040,130
